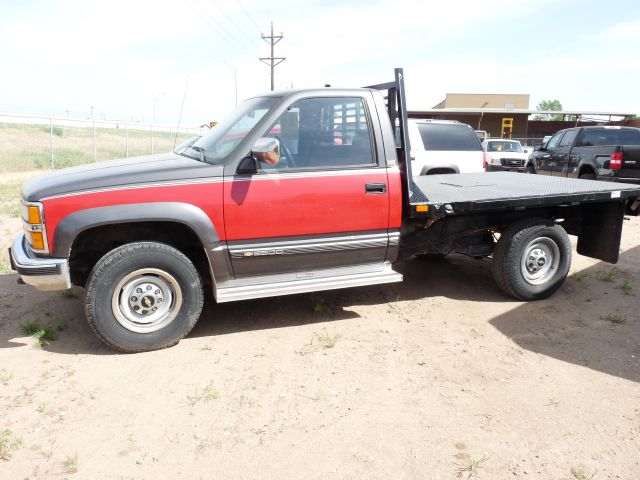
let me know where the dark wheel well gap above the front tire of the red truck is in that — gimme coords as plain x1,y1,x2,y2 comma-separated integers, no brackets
69,222,211,286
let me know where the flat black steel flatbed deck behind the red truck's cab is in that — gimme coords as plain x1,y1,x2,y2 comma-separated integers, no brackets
409,172,640,218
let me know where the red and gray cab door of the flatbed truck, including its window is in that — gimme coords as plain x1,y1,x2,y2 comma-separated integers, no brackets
224,97,389,278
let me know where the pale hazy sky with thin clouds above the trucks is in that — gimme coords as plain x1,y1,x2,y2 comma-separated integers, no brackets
0,0,640,126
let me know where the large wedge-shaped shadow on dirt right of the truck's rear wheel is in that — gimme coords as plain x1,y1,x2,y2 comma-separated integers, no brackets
490,247,640,382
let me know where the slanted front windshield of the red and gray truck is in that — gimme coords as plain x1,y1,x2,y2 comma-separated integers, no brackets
179,97,276,163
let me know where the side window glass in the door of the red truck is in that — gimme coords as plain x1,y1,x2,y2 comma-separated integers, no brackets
261,97,376,170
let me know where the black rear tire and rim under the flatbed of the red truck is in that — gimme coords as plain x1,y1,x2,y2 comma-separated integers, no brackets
492,218,571,300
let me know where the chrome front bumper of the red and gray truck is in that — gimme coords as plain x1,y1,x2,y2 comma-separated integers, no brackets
9,233,71,292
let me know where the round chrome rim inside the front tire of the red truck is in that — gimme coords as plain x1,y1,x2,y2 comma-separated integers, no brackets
111,268,182,333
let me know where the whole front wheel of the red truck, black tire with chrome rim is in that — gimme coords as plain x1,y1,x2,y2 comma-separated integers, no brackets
85,242,204,353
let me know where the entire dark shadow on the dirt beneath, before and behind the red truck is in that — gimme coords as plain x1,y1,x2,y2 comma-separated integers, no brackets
0,247,640,382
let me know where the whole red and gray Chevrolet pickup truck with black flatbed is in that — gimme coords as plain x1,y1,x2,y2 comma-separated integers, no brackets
10,69,640,352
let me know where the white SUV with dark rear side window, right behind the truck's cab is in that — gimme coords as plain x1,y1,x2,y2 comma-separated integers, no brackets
408,118,484,176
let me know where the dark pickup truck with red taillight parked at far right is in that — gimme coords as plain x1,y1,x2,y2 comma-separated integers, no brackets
526,127,640,183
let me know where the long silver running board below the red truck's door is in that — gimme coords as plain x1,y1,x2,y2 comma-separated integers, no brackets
216,263,402,303
